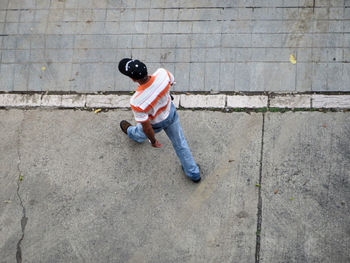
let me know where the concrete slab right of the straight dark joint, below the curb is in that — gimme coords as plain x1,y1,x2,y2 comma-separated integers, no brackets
260,113,350,263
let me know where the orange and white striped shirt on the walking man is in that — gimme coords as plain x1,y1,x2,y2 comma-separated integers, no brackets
130,68,174,124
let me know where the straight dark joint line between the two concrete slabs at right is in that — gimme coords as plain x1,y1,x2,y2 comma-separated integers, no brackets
255,113,265,263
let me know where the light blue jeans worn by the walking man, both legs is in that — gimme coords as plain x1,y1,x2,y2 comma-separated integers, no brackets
128,102,200,180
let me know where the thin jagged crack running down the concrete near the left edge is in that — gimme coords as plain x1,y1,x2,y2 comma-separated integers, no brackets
16,113,28,263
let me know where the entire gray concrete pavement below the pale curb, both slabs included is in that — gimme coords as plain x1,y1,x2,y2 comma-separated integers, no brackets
0,109,350,263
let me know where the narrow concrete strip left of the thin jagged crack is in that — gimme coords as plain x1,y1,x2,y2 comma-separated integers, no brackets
0,111,23,262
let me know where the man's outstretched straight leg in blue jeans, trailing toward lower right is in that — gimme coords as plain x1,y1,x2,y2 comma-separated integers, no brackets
164,113,200,181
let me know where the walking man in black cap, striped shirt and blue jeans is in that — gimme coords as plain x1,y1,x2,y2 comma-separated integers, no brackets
118,58,201,183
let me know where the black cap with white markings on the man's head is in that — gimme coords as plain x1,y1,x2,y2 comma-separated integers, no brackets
118,58,147,80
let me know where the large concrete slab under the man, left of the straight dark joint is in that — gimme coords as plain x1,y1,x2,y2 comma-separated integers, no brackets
0,110,262,262
